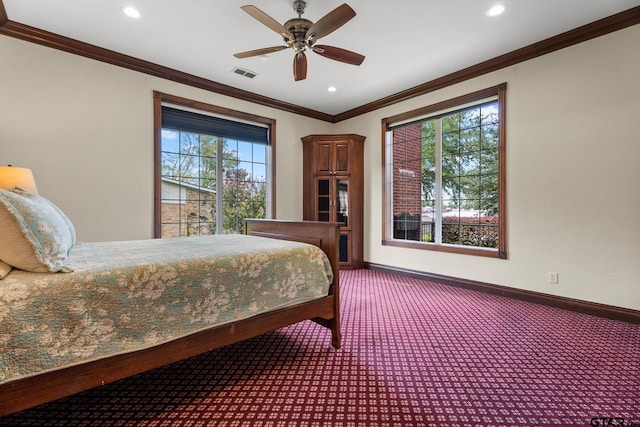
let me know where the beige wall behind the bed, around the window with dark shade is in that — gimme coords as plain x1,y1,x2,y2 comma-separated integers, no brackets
0,36,331,241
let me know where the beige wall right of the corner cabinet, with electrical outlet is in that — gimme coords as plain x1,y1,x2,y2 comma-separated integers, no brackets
335,25,640,310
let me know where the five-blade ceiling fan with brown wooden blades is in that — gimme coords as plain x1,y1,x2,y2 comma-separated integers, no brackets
233,0,364,81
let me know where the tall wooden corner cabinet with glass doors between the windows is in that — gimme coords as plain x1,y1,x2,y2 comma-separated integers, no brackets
302,134,365,269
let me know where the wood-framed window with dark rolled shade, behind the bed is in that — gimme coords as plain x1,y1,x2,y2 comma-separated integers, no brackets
154,93,275,237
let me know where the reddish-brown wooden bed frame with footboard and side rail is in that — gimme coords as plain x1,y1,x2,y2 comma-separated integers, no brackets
0,219,342,417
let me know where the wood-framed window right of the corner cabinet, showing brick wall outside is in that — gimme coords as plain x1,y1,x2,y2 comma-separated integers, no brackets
383,84,506,258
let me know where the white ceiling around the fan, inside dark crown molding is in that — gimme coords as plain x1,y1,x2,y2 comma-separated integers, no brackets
3,0,640,115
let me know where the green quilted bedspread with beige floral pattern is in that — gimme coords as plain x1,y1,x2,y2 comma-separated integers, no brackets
0,235,333,383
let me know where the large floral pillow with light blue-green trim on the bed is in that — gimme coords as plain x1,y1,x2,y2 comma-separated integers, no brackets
0,188,76,273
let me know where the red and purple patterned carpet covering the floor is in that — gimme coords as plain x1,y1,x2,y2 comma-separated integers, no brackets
0,270,640,427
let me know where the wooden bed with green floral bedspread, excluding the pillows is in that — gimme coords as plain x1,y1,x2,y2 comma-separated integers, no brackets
0,188,341,416
